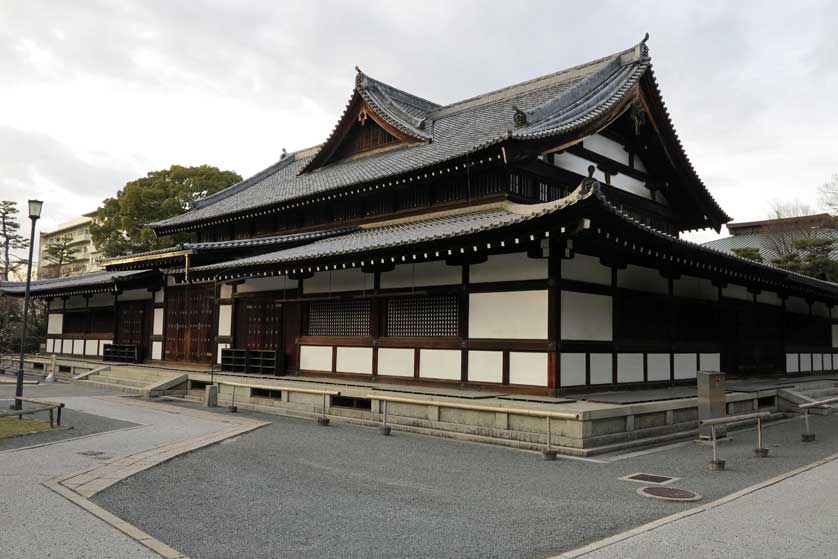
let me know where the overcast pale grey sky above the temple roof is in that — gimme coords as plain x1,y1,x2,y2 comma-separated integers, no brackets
0,0,838,245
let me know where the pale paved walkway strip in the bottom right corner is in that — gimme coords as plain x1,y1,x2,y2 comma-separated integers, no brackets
556,452,838,559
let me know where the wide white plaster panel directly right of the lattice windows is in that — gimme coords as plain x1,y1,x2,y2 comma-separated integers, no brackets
468,289,547,340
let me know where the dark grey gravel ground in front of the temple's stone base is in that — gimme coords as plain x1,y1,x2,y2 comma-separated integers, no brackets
94,406,838,559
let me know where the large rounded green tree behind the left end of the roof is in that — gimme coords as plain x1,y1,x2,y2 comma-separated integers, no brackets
90,165,242,256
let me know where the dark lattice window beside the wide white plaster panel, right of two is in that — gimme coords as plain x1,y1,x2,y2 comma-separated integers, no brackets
385,295,460,337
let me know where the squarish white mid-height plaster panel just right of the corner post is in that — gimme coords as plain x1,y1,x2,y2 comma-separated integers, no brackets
560,291,613,341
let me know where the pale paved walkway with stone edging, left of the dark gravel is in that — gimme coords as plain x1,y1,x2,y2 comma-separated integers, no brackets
0,386,266,559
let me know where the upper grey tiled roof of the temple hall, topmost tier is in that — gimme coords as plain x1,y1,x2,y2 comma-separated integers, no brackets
151,36,727,231
